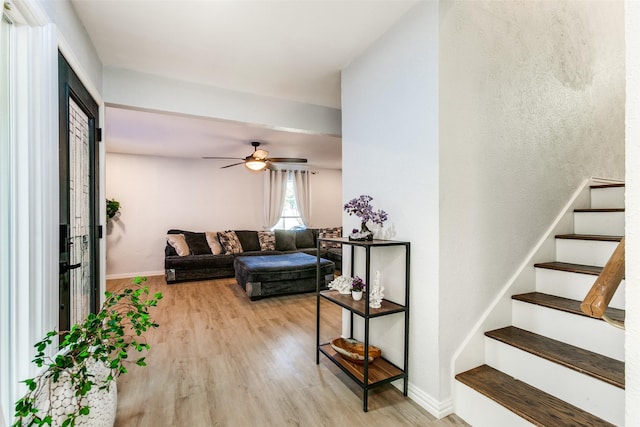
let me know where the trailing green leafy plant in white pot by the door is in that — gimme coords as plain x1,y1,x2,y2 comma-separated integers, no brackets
13,277,162,427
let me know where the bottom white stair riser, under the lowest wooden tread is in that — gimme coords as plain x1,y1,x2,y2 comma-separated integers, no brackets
454,381,534,427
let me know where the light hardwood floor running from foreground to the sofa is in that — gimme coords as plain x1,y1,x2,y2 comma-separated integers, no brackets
107,276,467,427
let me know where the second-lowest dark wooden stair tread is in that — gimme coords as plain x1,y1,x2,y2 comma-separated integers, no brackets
485,326,624,389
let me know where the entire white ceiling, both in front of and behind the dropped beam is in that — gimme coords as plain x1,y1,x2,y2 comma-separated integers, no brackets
72,0,418,168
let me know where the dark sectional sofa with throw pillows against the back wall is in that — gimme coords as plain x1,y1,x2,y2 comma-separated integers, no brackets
164,227,342,284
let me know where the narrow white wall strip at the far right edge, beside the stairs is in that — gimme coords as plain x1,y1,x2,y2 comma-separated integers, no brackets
625,2,640,426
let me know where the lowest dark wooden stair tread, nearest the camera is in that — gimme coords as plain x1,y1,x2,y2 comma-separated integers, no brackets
456,365,613,427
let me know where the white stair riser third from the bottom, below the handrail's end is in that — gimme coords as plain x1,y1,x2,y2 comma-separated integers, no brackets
511,300,624,361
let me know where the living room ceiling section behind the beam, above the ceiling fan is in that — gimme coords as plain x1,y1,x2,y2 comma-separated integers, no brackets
106,107,342,169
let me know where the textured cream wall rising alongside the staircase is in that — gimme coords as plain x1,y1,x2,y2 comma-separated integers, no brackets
440,1,625,402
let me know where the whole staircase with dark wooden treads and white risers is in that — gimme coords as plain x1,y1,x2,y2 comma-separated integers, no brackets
455,184,624,427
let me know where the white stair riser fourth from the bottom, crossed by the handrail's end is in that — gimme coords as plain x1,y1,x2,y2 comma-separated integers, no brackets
535,268,625,310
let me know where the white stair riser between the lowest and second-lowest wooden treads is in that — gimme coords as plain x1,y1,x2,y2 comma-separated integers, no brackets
485,337,624,425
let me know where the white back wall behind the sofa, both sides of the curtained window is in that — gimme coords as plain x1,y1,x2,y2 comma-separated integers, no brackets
106,153,341,278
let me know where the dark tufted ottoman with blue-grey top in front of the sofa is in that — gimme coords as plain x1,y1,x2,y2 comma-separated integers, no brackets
233,252,335,300
